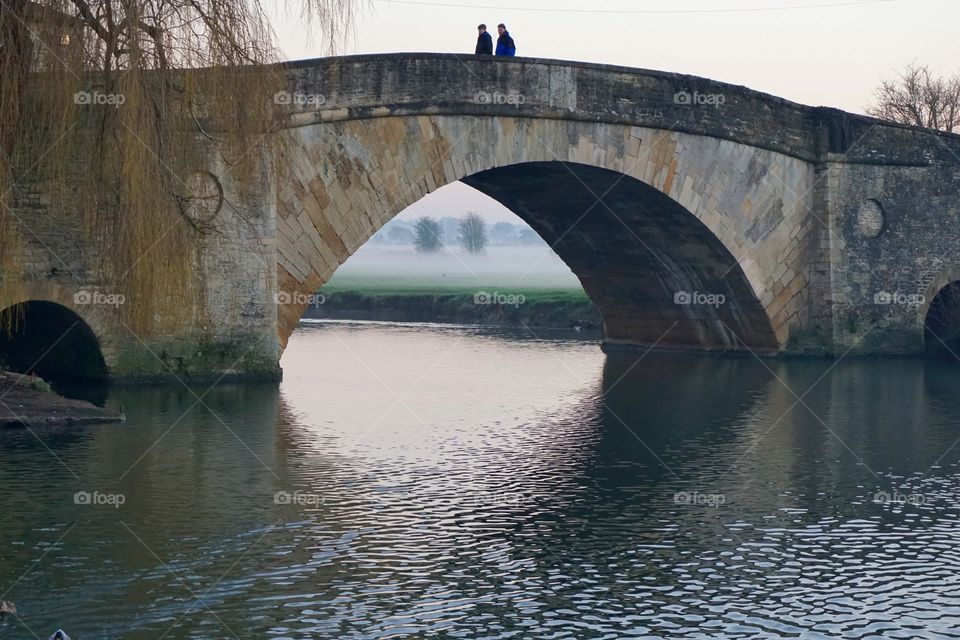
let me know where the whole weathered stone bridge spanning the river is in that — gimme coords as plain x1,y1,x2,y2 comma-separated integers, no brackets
0,54,960,379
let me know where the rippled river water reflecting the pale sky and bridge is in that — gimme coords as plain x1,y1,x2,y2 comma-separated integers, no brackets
0,322,960,640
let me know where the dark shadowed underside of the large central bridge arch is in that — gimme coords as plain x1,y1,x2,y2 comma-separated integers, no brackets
462,162,779,351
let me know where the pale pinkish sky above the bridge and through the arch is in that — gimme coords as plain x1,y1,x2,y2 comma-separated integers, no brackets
268,0,960,219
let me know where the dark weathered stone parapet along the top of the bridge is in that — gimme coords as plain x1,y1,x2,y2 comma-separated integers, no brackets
285,53,960,166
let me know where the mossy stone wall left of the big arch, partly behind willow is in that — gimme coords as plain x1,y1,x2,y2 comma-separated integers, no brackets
0,157,280,382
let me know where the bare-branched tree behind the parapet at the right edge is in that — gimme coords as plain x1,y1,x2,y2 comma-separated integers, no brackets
867,64,960,132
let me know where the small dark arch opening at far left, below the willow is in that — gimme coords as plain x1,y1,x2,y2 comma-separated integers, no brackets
0,300,107,383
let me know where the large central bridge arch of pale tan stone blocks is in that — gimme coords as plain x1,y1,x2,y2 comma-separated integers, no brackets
275,115,815,350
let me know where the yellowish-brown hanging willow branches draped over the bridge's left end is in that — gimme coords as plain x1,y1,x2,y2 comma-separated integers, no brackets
0,0,365,331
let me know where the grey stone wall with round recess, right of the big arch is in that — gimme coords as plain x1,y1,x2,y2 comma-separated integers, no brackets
830,157,960,354
